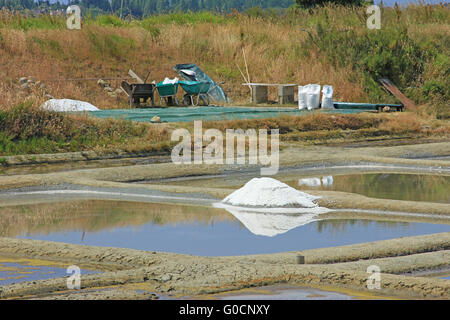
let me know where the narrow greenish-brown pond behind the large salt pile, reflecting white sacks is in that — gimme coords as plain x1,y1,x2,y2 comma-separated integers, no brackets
157,171,450,203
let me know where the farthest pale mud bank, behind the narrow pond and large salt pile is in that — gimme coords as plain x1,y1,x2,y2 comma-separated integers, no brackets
0,142,450,190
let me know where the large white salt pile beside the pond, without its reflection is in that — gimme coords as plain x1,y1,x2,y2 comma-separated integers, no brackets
222,178,320,208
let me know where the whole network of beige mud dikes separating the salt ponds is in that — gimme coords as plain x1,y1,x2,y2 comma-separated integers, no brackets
0,142,450,299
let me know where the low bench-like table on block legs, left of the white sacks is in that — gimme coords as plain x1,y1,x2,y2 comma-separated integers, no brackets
242,83,298,104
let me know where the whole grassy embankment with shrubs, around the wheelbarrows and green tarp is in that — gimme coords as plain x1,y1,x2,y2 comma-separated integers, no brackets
0,5,450,155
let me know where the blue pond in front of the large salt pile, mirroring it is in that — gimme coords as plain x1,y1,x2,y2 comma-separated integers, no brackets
0,200,450,256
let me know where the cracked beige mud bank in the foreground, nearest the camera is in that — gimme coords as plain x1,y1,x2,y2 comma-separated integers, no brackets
0,233,450,299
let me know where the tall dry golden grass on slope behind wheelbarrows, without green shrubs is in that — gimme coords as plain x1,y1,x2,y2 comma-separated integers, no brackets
0,6,449,109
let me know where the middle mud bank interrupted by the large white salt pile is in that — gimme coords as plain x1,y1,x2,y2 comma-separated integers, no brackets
0,180,450,220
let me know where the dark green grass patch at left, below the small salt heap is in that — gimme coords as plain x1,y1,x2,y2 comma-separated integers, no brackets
0,105,170,156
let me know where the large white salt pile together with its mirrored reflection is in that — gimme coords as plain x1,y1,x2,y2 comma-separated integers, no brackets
214,178,329,237
